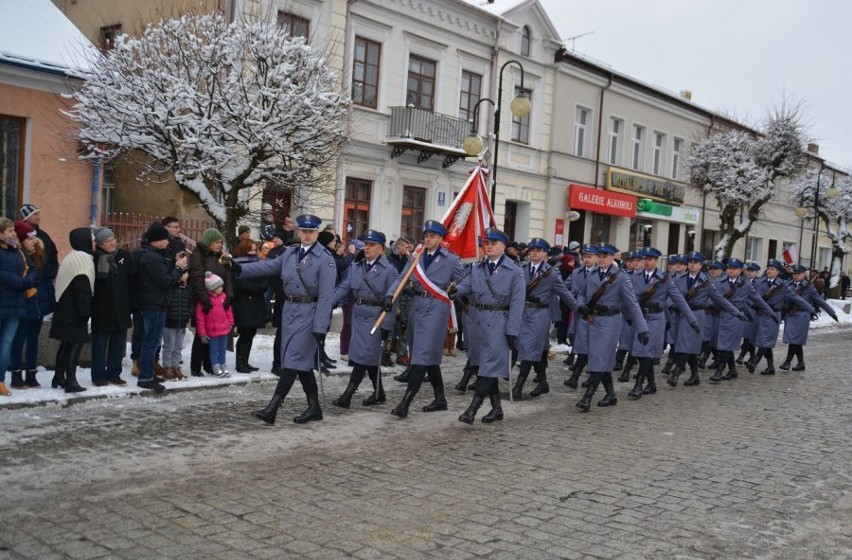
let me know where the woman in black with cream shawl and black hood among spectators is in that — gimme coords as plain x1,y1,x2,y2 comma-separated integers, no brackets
50,227,95,393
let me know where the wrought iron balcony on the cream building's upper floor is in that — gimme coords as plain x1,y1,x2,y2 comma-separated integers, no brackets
385,107,470,168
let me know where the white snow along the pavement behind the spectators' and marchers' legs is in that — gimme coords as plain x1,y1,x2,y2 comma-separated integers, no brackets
0,300,852,409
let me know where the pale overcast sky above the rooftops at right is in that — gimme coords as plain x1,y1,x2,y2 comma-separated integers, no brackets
540,0,852,169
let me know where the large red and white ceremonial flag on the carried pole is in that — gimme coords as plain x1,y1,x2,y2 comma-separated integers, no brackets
441,165,495,260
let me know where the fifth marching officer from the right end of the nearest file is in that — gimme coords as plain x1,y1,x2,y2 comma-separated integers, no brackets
627,247,700,400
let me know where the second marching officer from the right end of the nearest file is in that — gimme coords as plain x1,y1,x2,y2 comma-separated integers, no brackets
746,259,815,375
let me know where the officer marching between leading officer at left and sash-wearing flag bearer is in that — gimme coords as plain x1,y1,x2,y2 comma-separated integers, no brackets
331,229,398,408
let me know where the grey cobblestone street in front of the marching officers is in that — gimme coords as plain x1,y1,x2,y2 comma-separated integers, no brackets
0,329,852,559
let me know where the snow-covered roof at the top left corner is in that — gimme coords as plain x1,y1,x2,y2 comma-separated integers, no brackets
0,0,97,74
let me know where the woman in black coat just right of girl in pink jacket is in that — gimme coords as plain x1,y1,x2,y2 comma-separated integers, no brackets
234,239,268,373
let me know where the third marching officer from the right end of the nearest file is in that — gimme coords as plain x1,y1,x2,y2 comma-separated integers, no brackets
710,258,772,383
